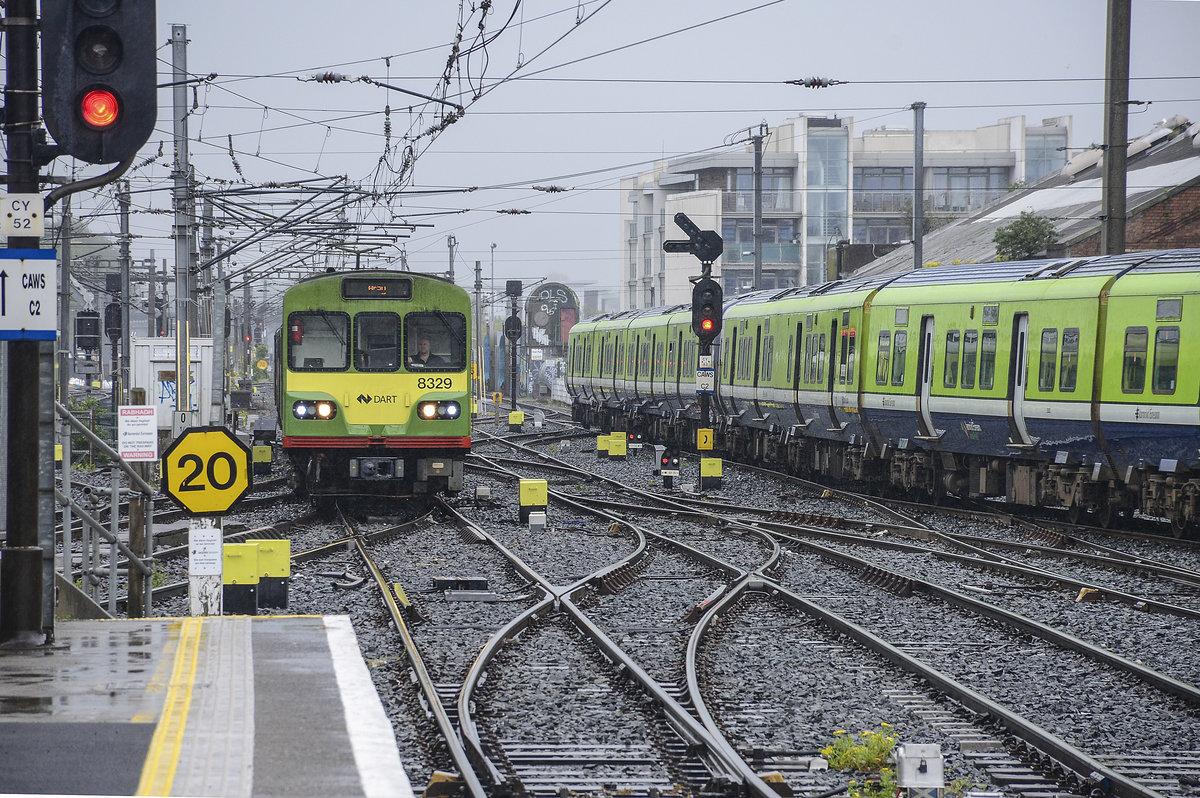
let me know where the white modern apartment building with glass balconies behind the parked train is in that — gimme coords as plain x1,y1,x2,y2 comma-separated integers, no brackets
618,116,1070,308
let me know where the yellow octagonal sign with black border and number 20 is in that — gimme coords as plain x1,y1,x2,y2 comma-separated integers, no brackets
162,427,252,515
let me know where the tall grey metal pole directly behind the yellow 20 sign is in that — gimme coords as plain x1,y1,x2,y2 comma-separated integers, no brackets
170,25,192,438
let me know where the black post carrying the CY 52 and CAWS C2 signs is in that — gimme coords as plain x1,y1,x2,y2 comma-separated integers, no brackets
0,0,46,647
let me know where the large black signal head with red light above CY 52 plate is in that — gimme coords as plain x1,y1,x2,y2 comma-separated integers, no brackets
42,0,158,163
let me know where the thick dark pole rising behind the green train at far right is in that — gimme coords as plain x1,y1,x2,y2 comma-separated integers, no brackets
1100,0,1132,254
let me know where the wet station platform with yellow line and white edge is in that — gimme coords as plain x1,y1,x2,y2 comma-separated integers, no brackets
0,616,413,798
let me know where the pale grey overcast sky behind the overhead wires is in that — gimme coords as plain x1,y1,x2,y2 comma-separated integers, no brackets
44,0,1200,300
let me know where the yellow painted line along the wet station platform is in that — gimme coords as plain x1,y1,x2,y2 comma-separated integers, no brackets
136,618,204,796
